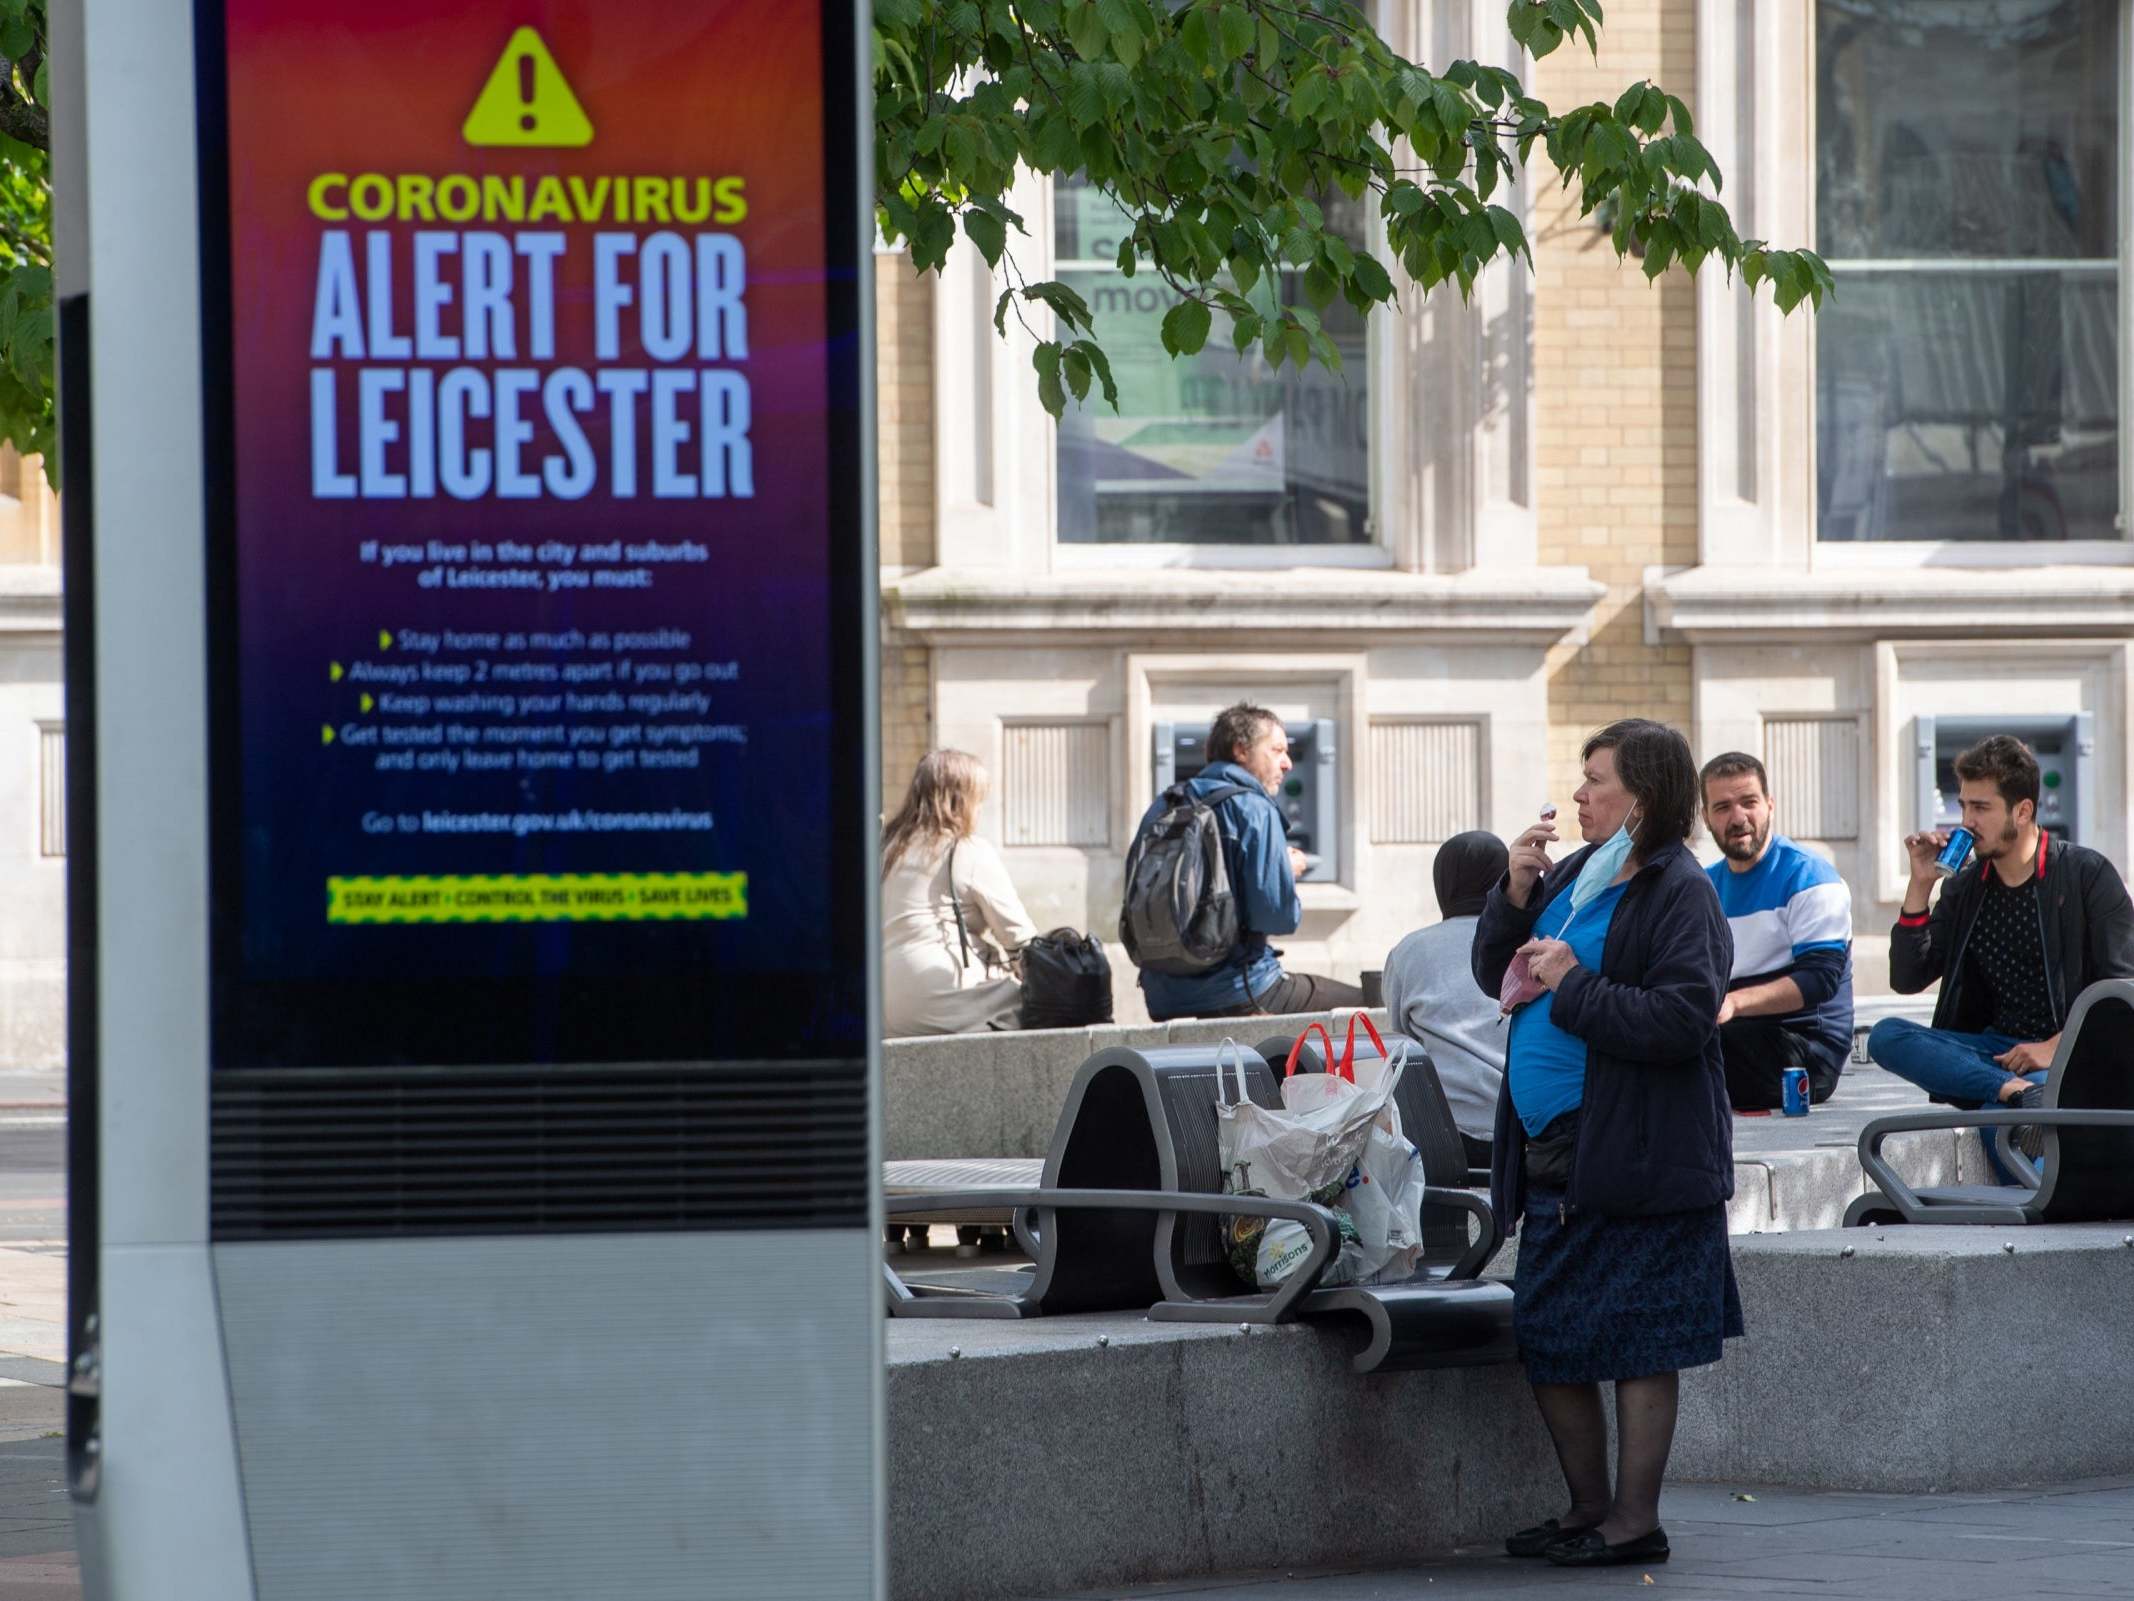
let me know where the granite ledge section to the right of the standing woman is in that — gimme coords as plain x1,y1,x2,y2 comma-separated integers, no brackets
1671,1223,2134,1492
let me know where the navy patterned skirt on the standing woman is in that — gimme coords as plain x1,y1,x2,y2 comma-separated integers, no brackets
1511,1189,1741,1383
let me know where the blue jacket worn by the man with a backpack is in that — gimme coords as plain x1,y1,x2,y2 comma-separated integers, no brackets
1135,762,1304,1018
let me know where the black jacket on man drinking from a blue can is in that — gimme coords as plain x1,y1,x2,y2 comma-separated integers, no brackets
1889,833,2134,1033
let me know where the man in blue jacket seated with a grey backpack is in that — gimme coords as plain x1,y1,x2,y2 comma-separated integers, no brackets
1118,702,1364,1023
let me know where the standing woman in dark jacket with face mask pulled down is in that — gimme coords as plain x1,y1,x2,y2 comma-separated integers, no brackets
1475,719,1741,1567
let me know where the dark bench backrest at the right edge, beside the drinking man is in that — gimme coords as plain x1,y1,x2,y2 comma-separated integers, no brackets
2032,980,2134,1223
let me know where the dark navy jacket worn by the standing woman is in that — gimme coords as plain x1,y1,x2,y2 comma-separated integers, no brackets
1475,845,1733,1230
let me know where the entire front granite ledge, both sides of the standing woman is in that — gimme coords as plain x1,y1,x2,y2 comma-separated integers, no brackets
886,1223,2134,1601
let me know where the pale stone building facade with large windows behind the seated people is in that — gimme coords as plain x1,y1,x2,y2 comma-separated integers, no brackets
877,0,2134,1028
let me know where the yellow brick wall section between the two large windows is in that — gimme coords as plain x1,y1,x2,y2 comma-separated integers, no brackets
1532,0,1697,777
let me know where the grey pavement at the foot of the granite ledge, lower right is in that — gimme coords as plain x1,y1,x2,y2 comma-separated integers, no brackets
1041,1477,2134,1601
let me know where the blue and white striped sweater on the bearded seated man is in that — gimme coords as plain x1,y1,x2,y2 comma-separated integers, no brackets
1705,835,1852,1072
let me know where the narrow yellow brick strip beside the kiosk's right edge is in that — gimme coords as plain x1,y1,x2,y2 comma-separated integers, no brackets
875,254,935,809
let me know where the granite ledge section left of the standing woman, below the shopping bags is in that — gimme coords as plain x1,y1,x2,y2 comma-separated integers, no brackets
888,1317,1562,1601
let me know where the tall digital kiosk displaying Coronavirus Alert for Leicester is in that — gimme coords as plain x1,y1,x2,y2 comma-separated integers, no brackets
51,0,883,1601
